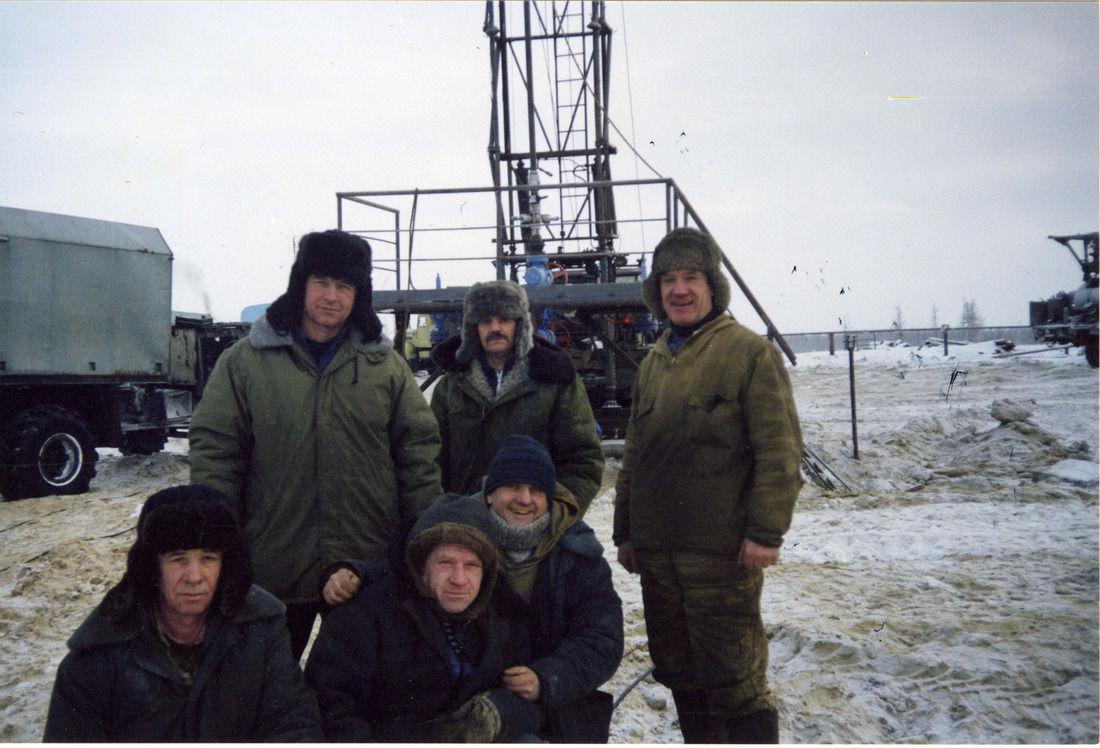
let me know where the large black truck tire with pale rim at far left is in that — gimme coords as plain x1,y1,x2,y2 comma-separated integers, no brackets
0,405,99,499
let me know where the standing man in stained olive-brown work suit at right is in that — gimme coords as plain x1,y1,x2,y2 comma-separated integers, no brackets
613,228,802,744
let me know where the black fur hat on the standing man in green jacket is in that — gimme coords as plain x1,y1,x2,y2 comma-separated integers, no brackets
261,229,382,342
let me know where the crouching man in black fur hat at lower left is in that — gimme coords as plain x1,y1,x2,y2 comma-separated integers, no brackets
44,485,321,743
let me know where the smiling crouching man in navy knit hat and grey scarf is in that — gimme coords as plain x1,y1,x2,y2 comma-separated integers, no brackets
475,435,623,743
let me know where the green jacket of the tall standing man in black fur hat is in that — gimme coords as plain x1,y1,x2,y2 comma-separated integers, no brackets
189,317,442,603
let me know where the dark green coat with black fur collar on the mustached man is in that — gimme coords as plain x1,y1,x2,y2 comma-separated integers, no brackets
431,336,604,514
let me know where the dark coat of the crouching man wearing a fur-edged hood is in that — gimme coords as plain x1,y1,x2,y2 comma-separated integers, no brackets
306,499,538,743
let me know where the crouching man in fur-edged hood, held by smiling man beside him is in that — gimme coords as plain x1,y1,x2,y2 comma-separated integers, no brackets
306,494,540,743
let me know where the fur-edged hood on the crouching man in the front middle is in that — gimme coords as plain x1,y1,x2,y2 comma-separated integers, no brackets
405,494,501,618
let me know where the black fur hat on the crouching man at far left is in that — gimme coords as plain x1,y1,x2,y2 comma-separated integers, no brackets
103,485,252,619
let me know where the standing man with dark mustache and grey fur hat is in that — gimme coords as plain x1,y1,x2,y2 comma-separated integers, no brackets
431,281,604,515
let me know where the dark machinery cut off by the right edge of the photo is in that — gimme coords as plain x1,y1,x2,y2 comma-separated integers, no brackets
1030,231,1100,369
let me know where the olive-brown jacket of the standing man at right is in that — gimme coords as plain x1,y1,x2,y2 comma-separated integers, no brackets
614,315,802,554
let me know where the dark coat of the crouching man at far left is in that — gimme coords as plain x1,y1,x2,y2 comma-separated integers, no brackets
44,586,321,743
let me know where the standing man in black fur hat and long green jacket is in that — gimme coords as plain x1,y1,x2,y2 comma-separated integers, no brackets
189,231,442,657
